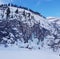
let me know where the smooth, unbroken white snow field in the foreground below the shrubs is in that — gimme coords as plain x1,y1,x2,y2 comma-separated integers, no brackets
0,48,60,59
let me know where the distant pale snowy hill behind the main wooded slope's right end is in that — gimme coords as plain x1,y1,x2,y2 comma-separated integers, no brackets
47,17,60,34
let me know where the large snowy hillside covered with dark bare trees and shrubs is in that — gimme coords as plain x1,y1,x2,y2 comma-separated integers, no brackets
0,5,60,51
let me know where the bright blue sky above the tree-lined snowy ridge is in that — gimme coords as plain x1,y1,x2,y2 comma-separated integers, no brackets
0,0,60,17
